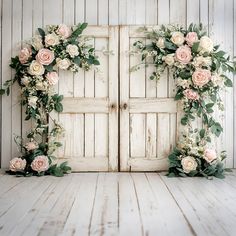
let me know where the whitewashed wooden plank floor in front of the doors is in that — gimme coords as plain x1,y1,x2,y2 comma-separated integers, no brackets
0,171,236,236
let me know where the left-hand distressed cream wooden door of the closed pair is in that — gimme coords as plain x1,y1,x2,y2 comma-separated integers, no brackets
57,26,118,171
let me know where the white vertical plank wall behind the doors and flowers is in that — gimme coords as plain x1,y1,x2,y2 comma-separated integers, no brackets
0,0,236,167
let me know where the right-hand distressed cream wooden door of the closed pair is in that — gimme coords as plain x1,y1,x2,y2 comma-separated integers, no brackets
120,26,178,171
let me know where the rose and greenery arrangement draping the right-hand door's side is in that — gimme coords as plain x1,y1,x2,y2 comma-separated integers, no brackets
133,24,236,178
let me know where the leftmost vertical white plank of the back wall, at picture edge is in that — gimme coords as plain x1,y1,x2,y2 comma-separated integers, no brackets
1,0,12,168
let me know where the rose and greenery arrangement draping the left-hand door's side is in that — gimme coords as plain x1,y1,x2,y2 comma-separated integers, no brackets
0,23,99,176
